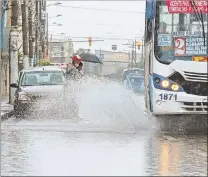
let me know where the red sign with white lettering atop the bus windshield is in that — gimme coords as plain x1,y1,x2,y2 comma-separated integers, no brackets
166,0,208,14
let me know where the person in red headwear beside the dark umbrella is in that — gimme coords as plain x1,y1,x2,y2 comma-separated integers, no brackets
67,55,83,79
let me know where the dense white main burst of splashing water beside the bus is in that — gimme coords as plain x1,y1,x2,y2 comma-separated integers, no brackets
66,77,152,131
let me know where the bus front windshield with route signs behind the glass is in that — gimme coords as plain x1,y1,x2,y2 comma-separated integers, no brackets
154,0,208,64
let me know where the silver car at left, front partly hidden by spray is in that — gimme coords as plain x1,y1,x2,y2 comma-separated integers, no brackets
10,66,76,118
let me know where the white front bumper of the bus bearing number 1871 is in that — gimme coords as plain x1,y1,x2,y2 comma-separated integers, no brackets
152,89,208,115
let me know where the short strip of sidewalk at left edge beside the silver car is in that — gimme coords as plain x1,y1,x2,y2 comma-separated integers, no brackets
1,97,13,120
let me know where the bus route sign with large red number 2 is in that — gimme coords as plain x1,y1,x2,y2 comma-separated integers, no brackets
174,37,207,56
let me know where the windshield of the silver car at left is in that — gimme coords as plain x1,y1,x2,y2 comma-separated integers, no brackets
21,71,64,86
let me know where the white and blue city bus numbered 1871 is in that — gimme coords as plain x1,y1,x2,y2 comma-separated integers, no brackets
144,0,208,115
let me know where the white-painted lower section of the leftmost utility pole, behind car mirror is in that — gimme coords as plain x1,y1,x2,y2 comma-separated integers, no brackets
9,27,19,104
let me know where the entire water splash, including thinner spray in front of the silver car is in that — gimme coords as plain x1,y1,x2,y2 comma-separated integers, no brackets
3,77,156,131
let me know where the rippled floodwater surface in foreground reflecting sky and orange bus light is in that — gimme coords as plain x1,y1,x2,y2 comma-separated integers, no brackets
1,121,207,176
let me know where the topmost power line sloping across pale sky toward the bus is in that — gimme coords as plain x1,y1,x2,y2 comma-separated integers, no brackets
54,5,145,14
